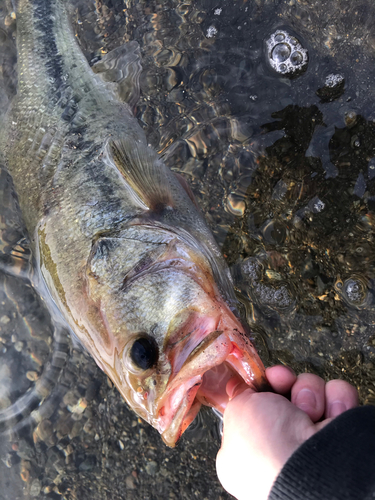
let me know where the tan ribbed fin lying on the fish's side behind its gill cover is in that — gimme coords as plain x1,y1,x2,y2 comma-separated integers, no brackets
109,137,174,212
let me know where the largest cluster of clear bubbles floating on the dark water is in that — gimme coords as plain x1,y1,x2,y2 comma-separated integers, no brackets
266,31,308,76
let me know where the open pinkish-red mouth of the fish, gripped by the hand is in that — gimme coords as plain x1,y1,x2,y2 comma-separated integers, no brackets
154,331,268,446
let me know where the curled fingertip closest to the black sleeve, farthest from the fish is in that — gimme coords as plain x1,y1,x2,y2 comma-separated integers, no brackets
325,380,359,418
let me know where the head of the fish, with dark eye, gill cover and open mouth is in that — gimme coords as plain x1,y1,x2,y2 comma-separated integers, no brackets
87,227,266,446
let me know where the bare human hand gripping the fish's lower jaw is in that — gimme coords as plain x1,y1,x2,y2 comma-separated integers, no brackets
216,366,358,500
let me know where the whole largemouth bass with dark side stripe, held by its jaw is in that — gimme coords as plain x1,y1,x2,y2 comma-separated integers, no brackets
0,0,267,446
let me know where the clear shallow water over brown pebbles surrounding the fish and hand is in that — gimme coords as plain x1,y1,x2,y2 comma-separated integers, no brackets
0,0,375,499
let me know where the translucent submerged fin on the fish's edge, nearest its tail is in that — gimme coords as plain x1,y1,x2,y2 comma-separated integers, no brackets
92,41,142,108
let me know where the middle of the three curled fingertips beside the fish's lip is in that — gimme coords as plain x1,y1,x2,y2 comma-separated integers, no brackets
291,373,325,422
